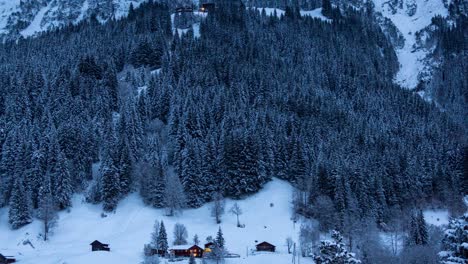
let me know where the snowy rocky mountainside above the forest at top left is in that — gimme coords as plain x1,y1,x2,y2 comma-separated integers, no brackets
0,0,146,39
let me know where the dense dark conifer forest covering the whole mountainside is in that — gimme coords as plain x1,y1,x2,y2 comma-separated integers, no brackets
0,1,468,262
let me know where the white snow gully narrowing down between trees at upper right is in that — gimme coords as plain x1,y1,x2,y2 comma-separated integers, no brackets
373,0,448,89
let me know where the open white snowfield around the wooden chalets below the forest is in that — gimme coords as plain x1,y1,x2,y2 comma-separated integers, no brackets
0,179,312,264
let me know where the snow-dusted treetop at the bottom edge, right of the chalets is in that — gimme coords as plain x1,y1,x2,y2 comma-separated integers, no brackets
314,230,361,264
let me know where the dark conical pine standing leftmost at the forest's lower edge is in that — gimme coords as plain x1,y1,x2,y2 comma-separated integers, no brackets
8,178,32,229
